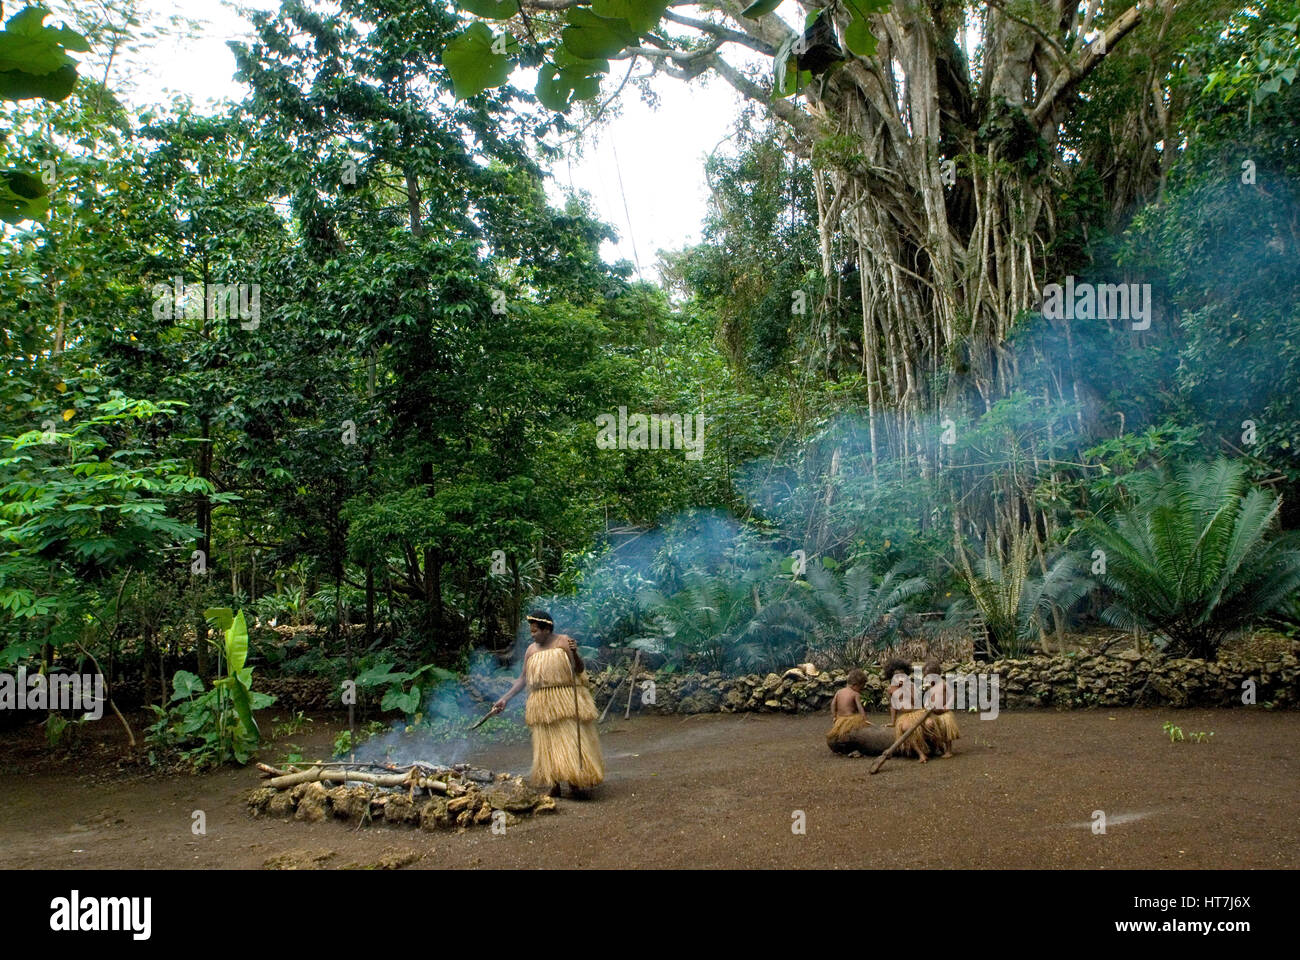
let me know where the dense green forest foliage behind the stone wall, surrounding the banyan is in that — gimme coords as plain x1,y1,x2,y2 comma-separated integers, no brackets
0,0,1300,764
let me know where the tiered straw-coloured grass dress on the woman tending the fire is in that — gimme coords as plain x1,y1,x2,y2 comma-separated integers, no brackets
524,647,605,790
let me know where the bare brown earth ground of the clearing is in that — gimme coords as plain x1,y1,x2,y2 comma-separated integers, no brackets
0,709,1300,869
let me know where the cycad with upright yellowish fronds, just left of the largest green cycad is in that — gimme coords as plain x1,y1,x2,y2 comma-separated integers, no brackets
957,529,1091,657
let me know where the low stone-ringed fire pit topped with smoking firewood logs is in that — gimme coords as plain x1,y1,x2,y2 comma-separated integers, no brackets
248,761,555,830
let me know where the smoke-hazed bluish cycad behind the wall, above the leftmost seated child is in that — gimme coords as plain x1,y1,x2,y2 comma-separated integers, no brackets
802,562,930,667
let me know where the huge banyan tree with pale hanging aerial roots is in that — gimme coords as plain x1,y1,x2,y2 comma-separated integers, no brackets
443,0,1236,556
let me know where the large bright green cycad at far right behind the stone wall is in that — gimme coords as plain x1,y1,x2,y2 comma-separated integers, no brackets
1087,457,1300,658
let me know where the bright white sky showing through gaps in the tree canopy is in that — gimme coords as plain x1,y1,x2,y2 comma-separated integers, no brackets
114,0,769,280
